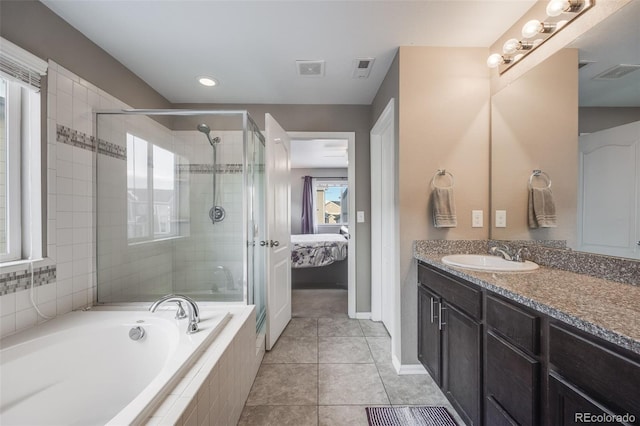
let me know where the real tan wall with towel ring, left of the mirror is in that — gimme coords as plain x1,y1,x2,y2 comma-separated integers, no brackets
398,47,489,364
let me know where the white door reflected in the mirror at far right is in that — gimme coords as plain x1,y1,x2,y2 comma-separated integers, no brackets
578,122,640,259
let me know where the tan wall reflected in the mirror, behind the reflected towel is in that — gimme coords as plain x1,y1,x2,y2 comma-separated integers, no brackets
491,49,578,243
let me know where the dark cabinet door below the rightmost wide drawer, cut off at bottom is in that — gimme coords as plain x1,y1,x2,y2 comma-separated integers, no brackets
549,373,638,426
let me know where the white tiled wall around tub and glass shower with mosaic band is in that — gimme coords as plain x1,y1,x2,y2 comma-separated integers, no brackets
0,61,244,336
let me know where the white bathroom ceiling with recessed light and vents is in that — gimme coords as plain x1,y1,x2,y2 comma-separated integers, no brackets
42,0,535,105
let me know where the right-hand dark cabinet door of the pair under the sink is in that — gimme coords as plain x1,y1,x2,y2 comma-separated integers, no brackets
441,300,482,425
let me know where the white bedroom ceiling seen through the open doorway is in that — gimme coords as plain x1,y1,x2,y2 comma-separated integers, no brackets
291,139,349,169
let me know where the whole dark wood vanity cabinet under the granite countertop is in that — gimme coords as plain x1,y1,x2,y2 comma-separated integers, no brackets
418,263,640,426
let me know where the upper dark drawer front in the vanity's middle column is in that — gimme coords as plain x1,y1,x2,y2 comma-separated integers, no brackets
486,295,540,355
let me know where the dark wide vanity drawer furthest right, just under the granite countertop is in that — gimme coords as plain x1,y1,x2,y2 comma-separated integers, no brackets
549,323,640,419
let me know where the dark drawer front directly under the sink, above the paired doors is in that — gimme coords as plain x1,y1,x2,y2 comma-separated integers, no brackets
418,264,482,319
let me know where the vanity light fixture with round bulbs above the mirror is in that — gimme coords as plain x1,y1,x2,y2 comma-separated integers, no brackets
487,0,595,73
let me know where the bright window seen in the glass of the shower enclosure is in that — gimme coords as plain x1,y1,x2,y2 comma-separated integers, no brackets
127,133,178,242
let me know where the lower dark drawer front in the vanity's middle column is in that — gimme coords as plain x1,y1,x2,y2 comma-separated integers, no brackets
485,332,540,426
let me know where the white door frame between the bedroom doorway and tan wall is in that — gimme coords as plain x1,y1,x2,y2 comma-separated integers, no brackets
370,98,400,336
